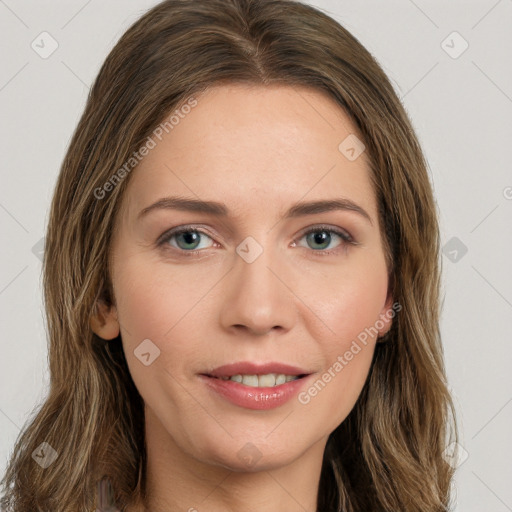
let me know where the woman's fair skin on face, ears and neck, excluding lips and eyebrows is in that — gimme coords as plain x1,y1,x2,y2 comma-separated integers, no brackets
91,85,392,512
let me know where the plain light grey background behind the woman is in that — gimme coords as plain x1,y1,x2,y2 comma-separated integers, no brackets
0,0,512,512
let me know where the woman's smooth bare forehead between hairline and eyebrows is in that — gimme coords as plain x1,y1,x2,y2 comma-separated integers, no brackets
119,84,374,217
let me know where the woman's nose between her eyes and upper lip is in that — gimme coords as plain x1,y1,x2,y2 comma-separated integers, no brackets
220,239,298,336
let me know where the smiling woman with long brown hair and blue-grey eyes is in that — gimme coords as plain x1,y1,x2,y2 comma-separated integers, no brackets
2,0,457,512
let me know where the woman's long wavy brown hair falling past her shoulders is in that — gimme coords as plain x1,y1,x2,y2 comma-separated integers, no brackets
2,0,457,512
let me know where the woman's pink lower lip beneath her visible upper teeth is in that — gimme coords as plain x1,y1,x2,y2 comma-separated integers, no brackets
199,374,313,410
